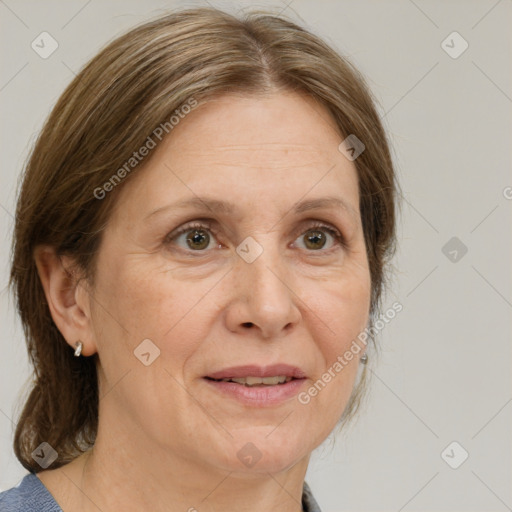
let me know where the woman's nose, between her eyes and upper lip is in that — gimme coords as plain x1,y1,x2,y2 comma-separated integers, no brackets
226,240,301,339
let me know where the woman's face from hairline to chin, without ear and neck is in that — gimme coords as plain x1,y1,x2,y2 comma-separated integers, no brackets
86,93,370,472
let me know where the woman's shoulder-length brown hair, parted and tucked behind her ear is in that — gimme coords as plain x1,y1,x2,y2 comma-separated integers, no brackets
10,8,396,472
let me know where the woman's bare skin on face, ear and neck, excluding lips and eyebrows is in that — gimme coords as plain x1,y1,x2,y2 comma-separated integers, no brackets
36,92,370,512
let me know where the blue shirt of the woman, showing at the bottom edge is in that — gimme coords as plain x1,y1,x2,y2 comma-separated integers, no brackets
0,473,321,512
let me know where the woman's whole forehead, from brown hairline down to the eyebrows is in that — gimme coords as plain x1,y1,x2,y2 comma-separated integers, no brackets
112,89,358,220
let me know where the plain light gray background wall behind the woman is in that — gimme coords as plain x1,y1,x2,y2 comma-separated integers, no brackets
0,0,512,512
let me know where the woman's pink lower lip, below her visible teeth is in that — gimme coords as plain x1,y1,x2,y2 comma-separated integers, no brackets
204,378,306,407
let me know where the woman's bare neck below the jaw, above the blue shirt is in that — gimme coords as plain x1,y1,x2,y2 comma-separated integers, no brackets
70,412,309,512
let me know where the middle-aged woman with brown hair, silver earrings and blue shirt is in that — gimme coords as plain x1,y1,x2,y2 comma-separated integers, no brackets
0,8,396,512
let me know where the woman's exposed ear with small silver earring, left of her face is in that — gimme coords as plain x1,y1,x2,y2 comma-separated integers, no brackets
34,246,96,356
